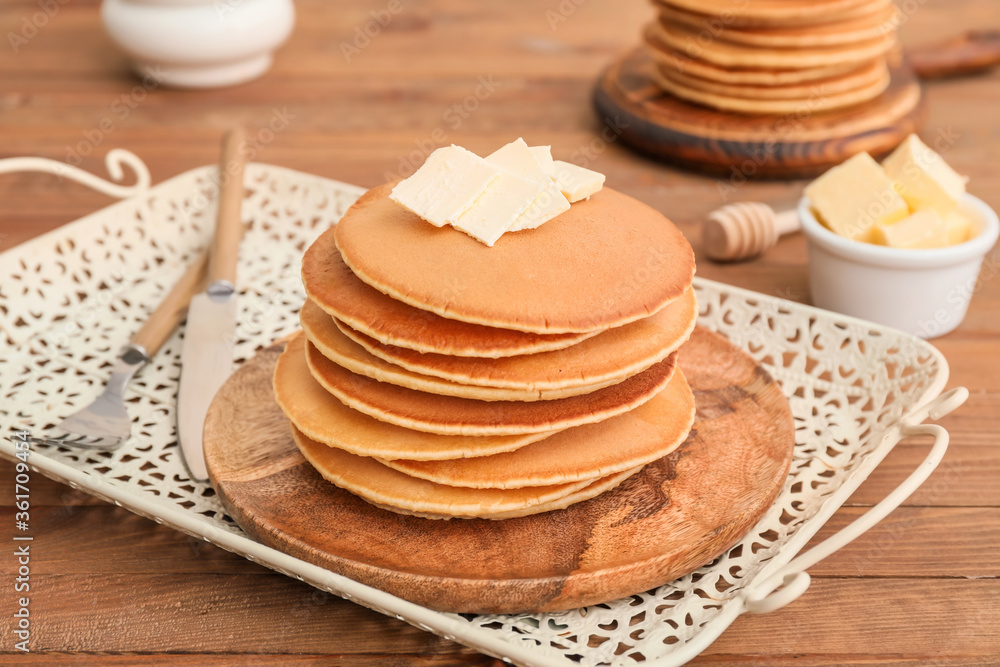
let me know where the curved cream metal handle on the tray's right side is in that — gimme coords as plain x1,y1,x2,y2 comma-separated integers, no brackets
742,387,969,614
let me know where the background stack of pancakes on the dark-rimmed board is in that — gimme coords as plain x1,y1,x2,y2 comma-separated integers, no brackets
644,0,898,114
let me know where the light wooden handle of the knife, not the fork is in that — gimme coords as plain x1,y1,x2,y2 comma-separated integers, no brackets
208,127,247,284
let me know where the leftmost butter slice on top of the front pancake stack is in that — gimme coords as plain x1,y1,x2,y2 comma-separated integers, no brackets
389,145,500,227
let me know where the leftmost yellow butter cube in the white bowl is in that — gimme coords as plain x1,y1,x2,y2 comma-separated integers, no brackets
805,153,910,241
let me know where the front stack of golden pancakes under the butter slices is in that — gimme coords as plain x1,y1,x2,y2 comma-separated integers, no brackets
274,184,697,519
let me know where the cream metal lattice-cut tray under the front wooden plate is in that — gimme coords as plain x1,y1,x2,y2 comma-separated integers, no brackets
0,159,964,665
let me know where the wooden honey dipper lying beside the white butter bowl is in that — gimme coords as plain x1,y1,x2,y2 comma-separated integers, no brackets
701,202,801,262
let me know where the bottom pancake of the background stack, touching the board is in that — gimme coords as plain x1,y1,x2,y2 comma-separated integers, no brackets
653,63,889,114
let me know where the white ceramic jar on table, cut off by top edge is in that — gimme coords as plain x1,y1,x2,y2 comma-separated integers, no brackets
101,0,295,88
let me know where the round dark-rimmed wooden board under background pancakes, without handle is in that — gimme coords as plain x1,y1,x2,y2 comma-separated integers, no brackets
594,48,923,179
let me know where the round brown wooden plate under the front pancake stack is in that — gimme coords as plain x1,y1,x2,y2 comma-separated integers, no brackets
204,329,794,613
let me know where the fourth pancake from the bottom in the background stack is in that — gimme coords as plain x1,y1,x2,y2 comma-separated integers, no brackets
645,21,896,69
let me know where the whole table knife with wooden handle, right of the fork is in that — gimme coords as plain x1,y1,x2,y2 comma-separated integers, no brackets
177,128,246,481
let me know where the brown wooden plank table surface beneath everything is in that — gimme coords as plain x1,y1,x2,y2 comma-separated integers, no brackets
0,0,1000,667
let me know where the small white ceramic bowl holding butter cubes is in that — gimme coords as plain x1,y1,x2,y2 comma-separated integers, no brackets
799,194,1000,338
